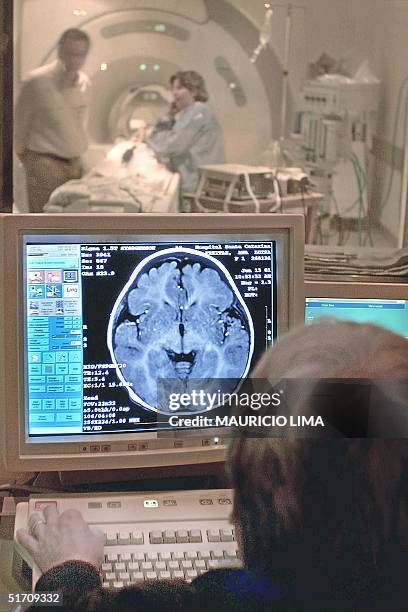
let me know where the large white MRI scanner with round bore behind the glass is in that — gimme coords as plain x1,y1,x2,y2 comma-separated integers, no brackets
14,0,291,212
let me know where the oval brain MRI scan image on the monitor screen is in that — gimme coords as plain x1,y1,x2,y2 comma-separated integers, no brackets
107,248,254,413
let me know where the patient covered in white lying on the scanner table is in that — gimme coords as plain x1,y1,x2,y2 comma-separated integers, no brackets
45,121,178,212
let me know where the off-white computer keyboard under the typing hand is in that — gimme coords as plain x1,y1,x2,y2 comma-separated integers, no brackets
14,489,240,588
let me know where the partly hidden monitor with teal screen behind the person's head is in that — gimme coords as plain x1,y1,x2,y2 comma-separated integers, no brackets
305,281,408,338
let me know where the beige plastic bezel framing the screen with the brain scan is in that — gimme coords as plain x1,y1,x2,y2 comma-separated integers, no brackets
0,214,304,471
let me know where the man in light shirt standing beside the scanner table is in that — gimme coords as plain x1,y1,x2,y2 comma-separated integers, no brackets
15,28,90,213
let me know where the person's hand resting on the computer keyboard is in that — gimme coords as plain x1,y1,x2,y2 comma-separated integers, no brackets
17,505,105,572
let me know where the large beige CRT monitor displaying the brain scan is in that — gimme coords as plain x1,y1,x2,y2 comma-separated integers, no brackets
0,214,304,471
